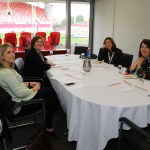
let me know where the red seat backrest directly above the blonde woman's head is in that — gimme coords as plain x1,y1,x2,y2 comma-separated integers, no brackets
4,32,17,47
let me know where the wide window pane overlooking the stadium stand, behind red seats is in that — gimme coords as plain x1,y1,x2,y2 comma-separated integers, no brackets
0,1,66,48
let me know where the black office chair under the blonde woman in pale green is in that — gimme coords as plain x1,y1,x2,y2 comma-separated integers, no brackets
0,86,45,150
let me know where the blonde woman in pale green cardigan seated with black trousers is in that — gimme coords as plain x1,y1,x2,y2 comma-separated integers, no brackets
0,43,59,135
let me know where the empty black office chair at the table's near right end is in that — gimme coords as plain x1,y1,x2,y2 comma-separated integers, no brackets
118,117,150,150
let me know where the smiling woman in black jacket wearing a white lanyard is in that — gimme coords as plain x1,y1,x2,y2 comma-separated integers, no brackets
98,37,122,66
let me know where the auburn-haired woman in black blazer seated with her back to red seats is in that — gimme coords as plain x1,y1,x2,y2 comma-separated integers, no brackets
22,36,54,87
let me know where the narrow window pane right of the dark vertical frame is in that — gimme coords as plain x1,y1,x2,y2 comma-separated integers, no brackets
71,2,90,46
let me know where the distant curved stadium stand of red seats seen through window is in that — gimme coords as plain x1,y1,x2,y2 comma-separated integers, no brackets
0,2,48,23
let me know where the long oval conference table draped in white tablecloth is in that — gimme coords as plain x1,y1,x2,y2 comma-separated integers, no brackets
47,55,150,150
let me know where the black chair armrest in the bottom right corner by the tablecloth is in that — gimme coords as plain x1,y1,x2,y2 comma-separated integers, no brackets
119,117,150,141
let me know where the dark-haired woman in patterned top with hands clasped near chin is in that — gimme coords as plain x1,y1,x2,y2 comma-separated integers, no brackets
130,39,150,80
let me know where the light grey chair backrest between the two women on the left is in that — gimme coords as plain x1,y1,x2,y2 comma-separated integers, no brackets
15,57,24,74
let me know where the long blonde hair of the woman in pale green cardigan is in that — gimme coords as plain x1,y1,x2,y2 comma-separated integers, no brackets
0,43,14,69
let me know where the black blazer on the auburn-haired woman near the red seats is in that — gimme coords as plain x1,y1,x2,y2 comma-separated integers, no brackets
22,48,51,77
